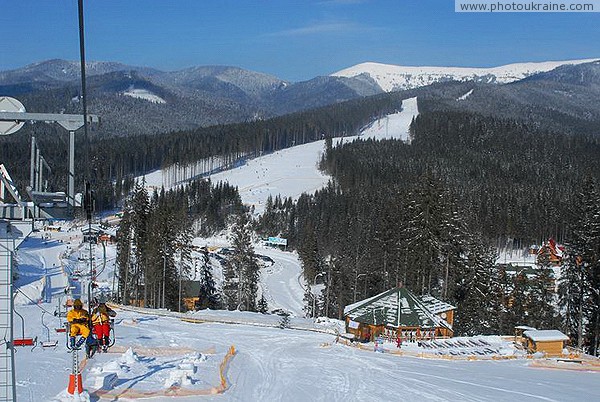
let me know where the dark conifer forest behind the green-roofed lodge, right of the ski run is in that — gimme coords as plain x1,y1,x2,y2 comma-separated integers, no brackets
257,112,600,352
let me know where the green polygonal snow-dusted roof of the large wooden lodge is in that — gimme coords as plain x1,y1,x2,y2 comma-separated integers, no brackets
344,288,452,329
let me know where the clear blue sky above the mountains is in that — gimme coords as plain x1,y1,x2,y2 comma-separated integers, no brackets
0,0,600,81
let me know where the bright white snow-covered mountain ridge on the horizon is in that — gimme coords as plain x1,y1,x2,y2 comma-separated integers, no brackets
331,59,597,92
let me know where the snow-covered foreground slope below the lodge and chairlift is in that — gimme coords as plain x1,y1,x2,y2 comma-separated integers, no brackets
11,296,600,401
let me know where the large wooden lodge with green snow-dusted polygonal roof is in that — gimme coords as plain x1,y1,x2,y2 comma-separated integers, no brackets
344,287,455,341
